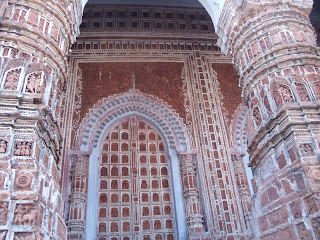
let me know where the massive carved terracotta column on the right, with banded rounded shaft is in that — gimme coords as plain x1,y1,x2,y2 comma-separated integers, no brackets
218,0,320,239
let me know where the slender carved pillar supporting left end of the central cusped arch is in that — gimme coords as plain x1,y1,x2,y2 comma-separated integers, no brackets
67,154,89,239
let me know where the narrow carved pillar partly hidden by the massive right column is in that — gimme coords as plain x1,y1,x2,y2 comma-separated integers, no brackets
231,151,251,231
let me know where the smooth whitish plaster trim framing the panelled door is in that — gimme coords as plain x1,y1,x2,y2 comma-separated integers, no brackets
85,112,188,240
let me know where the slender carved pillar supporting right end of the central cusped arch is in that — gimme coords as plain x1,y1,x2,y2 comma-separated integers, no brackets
179,154,204,235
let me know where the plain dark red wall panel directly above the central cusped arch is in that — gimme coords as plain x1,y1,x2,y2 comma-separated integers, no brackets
79,62,186,119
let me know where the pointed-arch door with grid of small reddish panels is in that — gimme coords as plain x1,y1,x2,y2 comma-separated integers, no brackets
97,116,177,240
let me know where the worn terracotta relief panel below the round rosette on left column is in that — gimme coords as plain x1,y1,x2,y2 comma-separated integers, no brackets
14,204,38,225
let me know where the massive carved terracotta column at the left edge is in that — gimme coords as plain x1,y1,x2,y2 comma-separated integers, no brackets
0,0,81,239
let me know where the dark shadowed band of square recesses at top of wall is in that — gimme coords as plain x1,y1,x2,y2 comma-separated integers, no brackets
80,5,214,35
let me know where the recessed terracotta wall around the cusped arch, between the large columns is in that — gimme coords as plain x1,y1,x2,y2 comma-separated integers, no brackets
63,6,249,239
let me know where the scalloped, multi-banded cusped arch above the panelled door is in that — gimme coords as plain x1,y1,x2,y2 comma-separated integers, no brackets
75,90,193,152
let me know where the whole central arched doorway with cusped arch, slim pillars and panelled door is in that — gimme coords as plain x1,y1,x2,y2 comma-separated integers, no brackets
68,89,204,240
